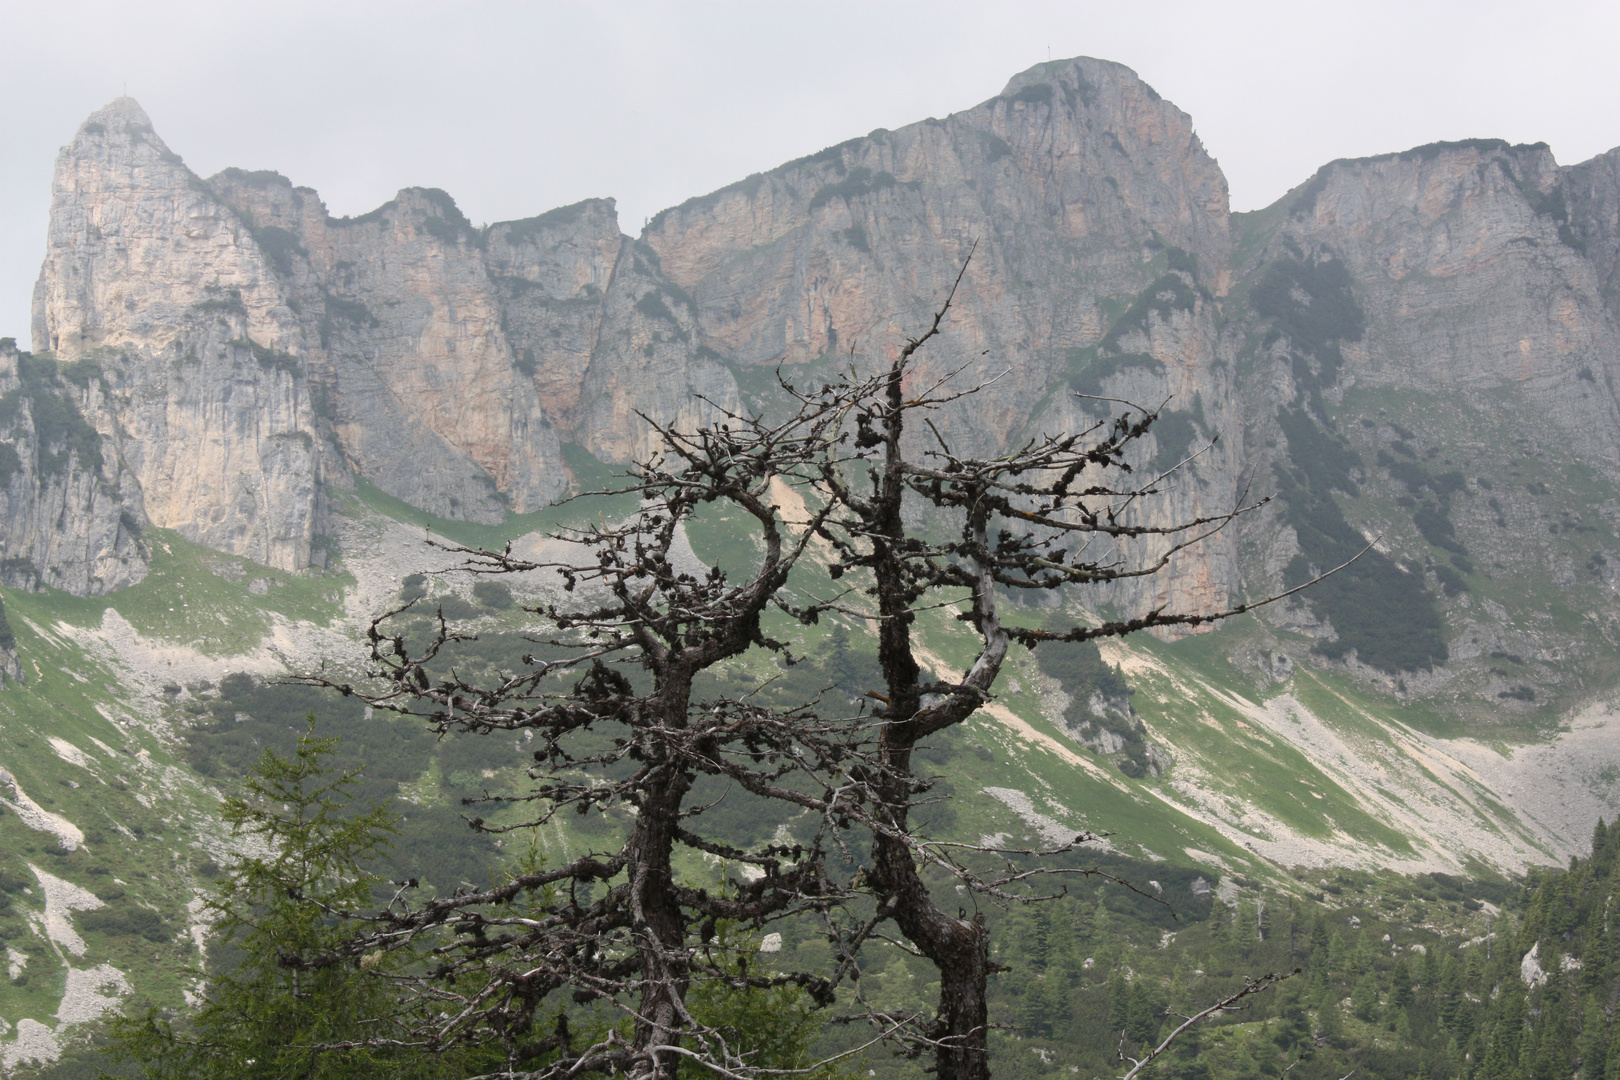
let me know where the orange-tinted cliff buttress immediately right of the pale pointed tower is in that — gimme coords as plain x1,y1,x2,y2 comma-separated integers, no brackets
209,170,565,521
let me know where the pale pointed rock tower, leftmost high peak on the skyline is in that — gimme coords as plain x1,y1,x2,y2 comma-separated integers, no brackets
34,99,319,570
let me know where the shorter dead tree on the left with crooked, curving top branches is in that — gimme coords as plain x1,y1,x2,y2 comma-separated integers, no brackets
306,399,887,1078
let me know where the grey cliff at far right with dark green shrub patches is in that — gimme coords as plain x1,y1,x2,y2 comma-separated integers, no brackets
1225,139,1620,702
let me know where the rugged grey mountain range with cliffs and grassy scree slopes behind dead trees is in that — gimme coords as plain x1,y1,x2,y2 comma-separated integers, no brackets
0,58,1620,1067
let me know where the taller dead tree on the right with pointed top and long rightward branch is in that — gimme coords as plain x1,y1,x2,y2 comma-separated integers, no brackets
795,266,1328,1080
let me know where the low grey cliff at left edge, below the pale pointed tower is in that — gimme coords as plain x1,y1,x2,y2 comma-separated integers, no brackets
0,338,147,595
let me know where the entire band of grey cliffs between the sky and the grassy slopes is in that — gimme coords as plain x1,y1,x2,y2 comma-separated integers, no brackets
22,58,1620,699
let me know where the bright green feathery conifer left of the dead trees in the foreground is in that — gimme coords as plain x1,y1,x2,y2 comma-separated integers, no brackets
112,716,466,1080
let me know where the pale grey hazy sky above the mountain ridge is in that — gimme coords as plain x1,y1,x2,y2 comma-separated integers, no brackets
0,0,1620,342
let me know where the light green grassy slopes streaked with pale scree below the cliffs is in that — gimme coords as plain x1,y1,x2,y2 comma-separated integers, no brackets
0,489,1594,1075
